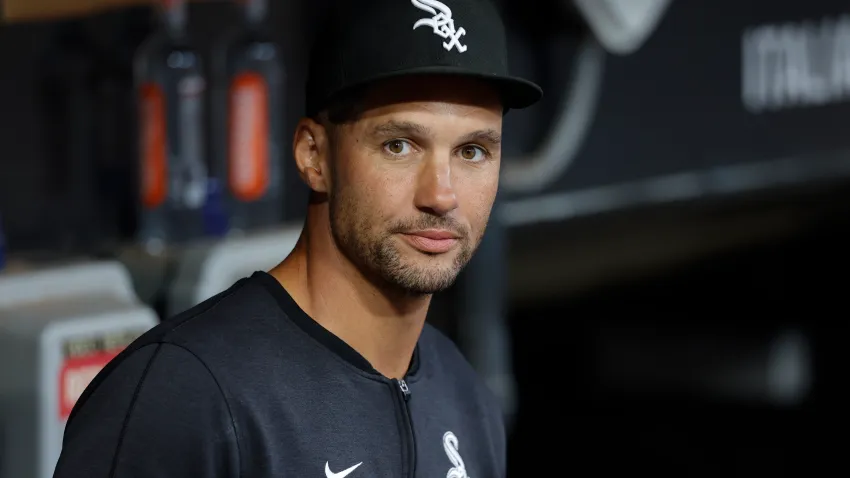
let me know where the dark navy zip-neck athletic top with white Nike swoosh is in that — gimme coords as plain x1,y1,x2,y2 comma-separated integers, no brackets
54,272,505,478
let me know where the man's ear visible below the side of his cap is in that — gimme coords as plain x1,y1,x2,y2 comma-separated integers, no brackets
292,118,332,193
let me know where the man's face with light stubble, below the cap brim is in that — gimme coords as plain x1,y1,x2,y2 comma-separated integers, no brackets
329,78,503,294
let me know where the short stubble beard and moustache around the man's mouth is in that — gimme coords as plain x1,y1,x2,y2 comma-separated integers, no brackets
328,177,486,296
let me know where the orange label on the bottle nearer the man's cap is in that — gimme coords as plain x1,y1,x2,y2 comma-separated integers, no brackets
228,72,270,201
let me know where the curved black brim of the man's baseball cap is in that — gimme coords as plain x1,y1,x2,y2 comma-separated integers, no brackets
318,66,543,110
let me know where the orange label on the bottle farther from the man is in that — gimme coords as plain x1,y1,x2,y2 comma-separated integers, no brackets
139,84,168,209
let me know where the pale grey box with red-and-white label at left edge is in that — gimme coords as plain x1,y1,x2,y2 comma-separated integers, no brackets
0,261,159,478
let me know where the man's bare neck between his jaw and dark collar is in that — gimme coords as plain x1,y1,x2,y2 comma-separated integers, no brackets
271,213,431,378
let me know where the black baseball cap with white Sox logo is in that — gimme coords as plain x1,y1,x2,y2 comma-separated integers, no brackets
306,0,543,116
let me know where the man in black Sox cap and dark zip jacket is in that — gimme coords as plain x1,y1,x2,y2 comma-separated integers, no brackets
55,0,541,478
